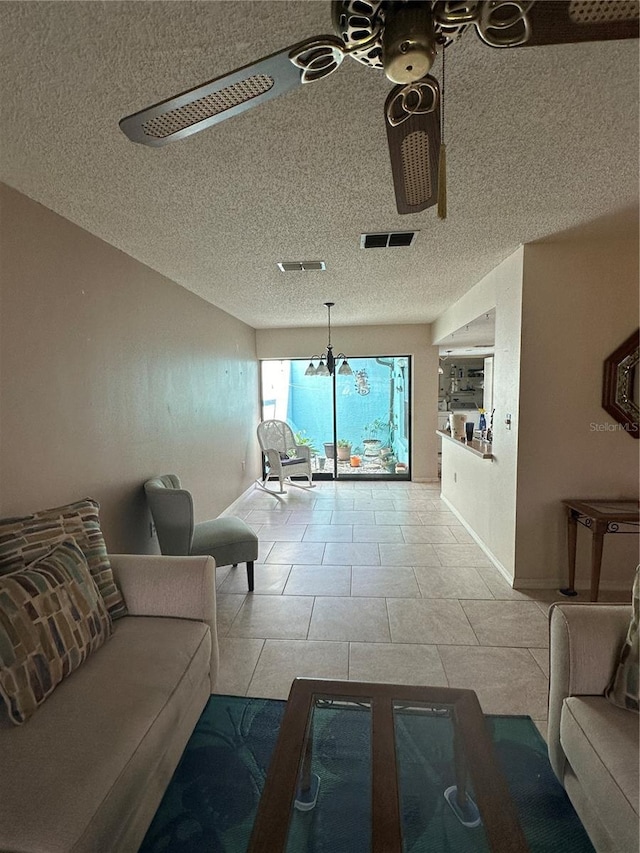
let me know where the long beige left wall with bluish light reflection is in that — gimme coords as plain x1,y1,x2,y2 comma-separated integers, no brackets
0,185,259,552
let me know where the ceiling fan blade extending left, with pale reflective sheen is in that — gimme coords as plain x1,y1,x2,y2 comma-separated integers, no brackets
120,36,345,147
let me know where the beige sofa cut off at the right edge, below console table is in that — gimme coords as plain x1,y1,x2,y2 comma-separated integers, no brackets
548,603,640,853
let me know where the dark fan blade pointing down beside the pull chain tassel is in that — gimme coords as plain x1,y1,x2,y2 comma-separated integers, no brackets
384,75,440,213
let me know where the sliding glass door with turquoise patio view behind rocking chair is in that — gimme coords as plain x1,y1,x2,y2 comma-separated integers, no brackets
261,356,411,479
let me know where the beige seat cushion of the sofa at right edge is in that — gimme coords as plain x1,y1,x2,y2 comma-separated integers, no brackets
560,696,640,850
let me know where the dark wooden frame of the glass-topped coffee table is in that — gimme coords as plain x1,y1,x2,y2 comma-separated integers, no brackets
248,678,529,853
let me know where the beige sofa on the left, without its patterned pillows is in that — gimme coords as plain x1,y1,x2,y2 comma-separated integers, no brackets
0,555,218,853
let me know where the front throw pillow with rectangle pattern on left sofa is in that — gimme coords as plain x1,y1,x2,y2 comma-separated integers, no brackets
0,539,111,725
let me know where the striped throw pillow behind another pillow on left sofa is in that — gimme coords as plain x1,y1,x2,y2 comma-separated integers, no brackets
0,498,127,619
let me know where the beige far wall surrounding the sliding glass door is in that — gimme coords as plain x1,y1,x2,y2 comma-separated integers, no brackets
256,322,438,481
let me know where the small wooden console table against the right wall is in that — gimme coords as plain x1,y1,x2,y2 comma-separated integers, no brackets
560,498,640,601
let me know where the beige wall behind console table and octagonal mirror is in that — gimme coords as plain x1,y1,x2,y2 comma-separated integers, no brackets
516,238,640,588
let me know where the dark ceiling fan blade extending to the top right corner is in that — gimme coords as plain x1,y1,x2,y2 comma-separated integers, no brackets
468,0,638,47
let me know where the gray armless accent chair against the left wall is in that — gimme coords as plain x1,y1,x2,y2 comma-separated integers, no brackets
144,474,258,592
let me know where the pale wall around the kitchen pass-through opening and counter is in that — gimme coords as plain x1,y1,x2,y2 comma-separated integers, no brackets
434,248,523,579
